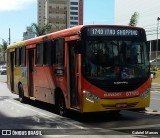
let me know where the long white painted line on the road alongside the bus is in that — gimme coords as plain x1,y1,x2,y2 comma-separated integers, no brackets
5,100,86,129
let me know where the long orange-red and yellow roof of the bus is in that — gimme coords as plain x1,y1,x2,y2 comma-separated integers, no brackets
7,24,143,49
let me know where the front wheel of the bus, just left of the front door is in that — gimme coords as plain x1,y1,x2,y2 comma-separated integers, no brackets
56,92,67,117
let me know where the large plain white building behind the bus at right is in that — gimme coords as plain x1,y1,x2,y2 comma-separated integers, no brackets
115,0,160,60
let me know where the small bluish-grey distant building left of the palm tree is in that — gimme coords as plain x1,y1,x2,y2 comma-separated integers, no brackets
23,26,35,40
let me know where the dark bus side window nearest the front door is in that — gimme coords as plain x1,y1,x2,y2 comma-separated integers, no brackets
54,38,65,65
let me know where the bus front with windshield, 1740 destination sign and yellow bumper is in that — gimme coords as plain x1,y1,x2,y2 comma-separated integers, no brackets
79,26,151,112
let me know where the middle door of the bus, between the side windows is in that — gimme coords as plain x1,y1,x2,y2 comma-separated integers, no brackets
28,48,34,97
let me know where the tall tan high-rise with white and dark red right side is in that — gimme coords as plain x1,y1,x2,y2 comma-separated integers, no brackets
37,0,83,32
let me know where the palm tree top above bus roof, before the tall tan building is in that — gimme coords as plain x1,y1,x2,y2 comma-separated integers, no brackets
31,23,51,36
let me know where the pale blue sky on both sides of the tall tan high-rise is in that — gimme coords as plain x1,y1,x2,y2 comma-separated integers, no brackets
0,0,114,44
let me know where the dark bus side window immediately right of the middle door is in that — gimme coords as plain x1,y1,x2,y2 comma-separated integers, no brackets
36,43,44,66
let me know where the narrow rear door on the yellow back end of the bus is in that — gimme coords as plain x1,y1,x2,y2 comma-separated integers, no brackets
9,52,14,91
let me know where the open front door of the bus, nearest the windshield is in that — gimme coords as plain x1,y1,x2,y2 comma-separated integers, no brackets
68,41,80,109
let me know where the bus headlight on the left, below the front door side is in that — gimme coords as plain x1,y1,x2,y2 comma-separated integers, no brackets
83,91,100,102
